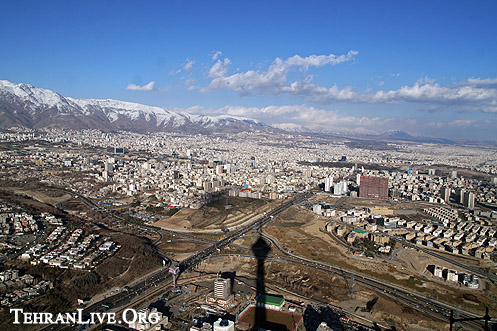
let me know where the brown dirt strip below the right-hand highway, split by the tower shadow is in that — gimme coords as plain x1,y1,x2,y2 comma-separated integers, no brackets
199,257,447,330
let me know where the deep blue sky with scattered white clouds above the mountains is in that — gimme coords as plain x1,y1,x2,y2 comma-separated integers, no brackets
0,0,497,140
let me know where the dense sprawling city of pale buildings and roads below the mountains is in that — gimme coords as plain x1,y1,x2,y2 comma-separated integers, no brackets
0,128,497,330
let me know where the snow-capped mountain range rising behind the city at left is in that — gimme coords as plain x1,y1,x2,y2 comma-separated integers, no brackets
0,80,271,133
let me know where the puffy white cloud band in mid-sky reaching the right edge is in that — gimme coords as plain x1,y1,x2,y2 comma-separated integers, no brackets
201,51,497,112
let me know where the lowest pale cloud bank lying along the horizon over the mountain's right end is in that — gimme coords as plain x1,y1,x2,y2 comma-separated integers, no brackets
170,104,495,140
